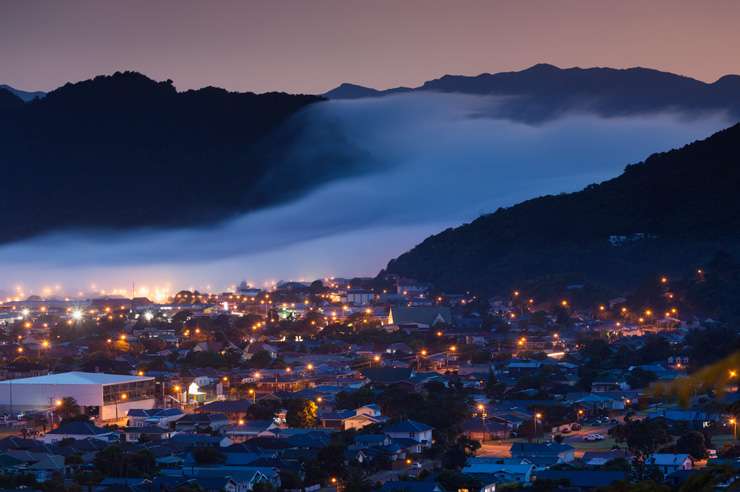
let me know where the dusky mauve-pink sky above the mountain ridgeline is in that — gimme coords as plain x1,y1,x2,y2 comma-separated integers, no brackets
0,0,740,93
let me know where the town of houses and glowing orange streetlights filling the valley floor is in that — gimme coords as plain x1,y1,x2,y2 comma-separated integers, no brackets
0,269,740,490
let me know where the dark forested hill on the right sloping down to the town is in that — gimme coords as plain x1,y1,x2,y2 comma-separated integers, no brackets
387,125,740,293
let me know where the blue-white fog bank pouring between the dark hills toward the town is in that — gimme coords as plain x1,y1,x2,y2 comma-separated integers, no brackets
0,93,731,291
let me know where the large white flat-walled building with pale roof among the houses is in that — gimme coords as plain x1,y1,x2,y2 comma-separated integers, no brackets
0,372,155,420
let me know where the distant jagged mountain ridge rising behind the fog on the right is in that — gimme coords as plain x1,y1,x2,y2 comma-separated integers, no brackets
326,64,740,121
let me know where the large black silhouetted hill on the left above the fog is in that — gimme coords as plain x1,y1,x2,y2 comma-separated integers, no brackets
0,72,322,242
